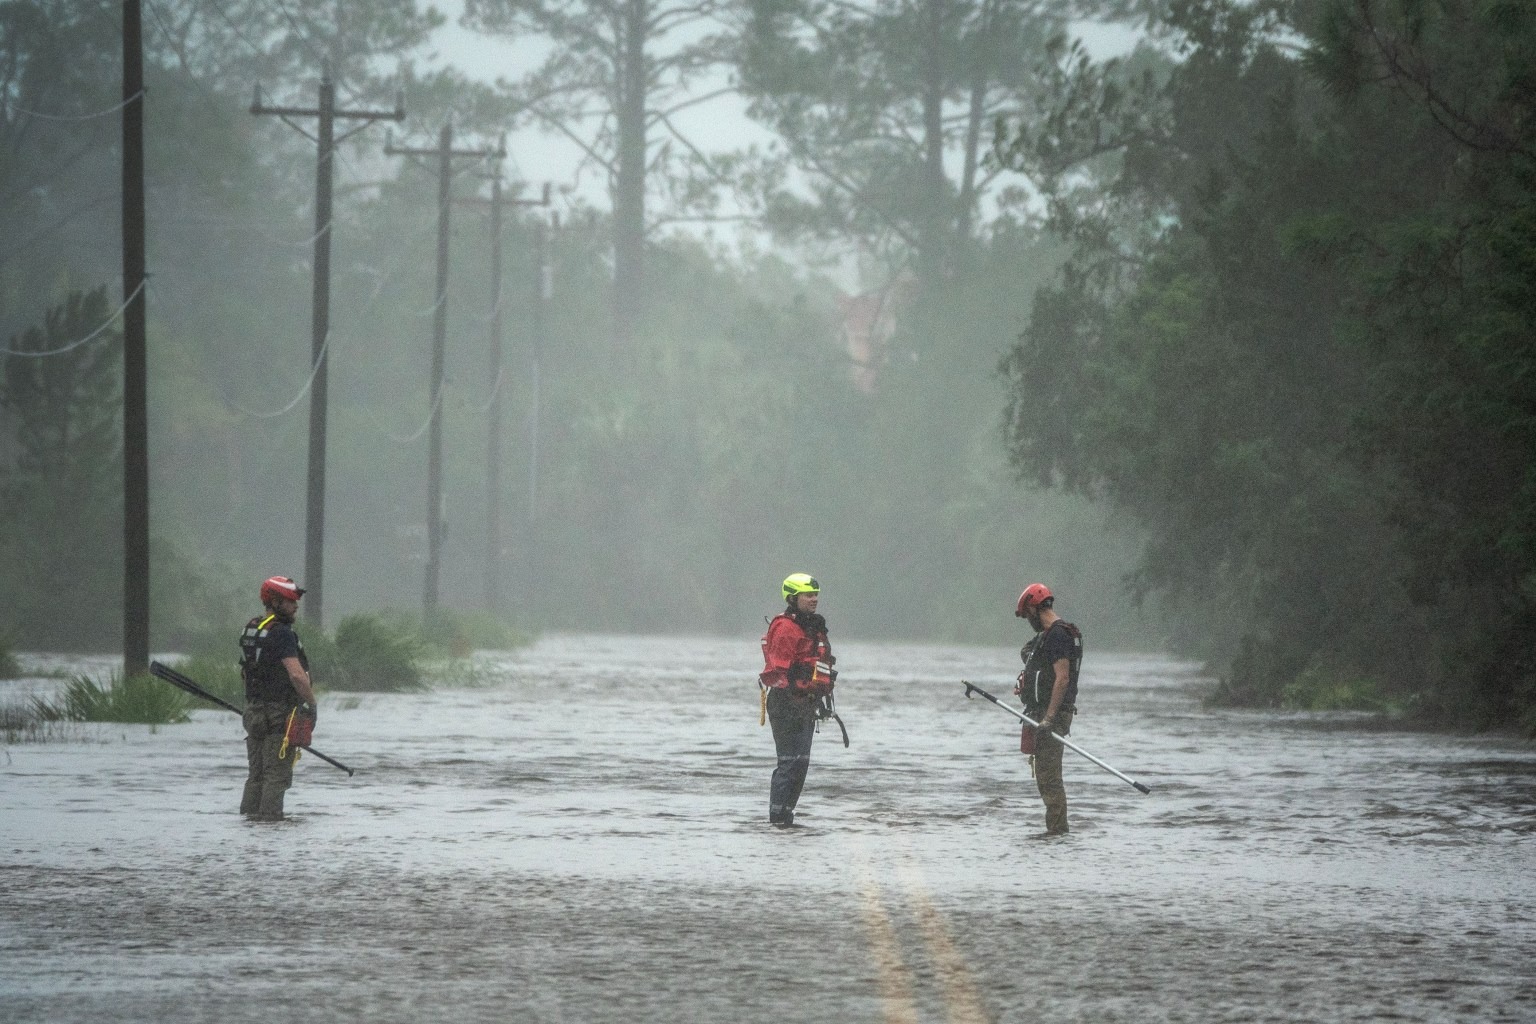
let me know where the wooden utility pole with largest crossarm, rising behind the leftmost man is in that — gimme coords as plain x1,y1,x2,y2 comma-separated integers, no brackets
250,64,406,629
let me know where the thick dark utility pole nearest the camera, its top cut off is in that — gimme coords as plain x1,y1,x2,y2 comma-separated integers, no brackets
123,0,149,679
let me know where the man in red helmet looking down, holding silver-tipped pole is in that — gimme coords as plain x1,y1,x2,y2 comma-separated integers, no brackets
1014,583,1083,835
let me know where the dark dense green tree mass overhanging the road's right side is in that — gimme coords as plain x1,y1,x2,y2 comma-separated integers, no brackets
1003,0,1536,723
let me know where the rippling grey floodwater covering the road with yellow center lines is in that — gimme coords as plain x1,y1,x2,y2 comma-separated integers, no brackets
0,636,1536,1024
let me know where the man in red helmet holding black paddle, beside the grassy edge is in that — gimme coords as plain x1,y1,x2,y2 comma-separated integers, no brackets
240,576,318,821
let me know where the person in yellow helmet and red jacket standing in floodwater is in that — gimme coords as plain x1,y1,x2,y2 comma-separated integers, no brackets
757,573,837,827
